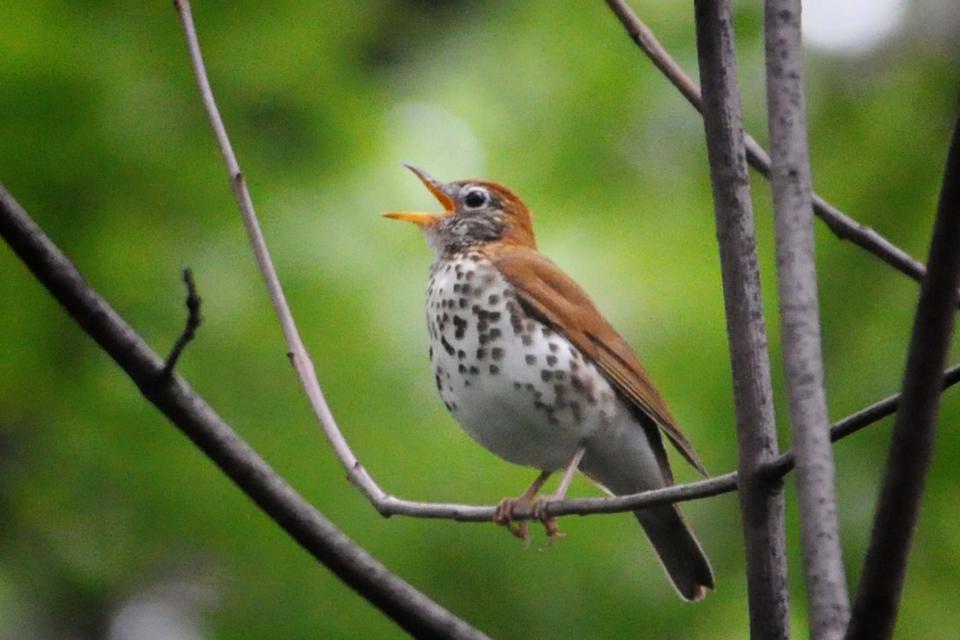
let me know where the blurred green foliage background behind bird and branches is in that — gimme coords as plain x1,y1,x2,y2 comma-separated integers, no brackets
0,0,960,639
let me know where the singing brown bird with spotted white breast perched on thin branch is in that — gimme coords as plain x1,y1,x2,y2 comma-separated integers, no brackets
384,164,714,601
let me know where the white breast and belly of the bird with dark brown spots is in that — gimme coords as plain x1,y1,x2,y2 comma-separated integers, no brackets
427,251,623,471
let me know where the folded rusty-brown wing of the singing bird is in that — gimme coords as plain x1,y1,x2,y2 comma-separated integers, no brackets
487,245,707,477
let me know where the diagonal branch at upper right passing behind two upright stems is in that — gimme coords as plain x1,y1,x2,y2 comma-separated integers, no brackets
606,0,926,281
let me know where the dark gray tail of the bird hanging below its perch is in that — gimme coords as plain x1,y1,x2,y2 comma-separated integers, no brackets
634,504,713,602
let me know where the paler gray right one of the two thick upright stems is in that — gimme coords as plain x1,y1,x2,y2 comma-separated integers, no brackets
764,0,850,640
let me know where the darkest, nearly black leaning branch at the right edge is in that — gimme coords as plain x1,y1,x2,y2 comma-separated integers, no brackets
847,107,960,640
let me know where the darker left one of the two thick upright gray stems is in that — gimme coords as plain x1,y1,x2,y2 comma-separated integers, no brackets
694,0,790,639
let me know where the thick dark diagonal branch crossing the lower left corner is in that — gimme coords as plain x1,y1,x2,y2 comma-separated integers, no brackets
0,186,486,638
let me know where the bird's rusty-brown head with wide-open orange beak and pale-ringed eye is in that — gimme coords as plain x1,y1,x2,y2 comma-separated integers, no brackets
386,164,537,256
